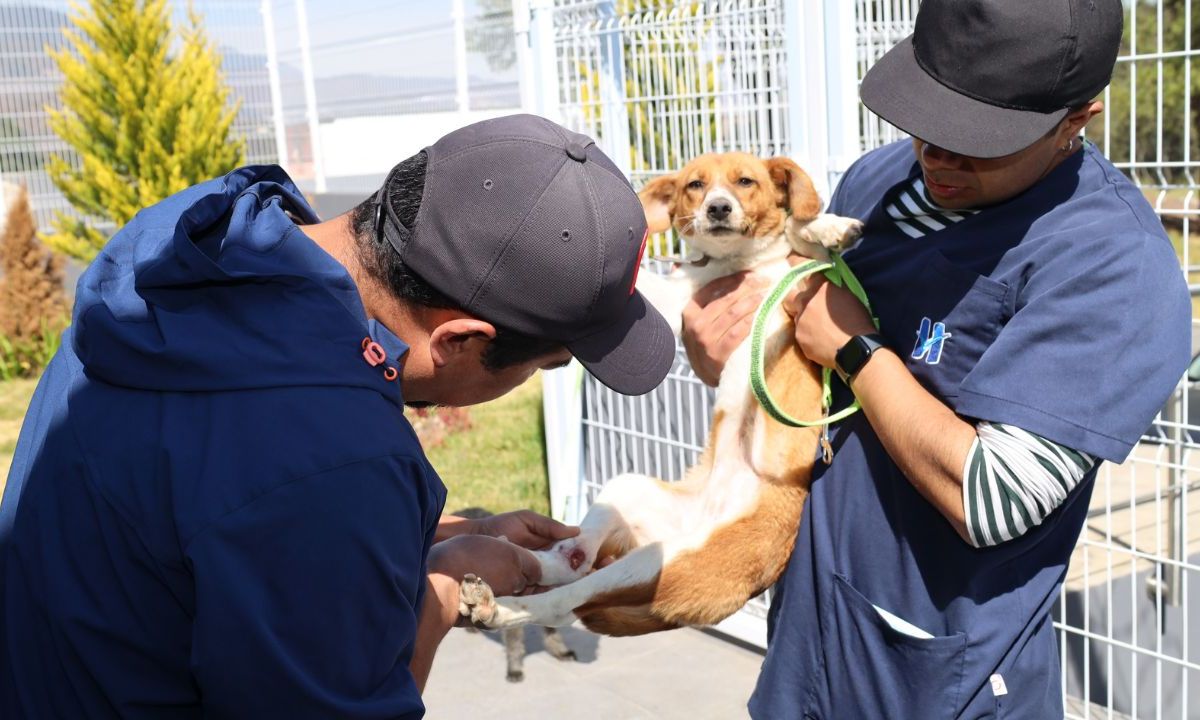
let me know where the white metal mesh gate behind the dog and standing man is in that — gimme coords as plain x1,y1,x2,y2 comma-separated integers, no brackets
535,0,1200,720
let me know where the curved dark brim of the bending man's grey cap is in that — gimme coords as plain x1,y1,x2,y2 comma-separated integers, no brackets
566,292,674,395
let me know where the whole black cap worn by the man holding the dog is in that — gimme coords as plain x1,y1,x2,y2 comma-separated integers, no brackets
859,0,1124,157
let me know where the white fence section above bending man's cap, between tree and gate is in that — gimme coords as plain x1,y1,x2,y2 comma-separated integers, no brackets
262,0,521,192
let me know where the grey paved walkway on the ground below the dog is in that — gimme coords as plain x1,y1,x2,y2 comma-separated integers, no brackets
425,628,762,720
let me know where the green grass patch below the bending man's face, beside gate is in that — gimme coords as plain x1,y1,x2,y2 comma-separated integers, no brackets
428,374,550,514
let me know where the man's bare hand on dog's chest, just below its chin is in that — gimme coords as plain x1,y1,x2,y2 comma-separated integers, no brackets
683,272,768,386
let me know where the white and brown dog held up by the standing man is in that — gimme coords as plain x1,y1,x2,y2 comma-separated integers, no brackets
460,152,860,635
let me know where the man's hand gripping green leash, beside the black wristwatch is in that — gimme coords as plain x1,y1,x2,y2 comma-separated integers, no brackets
784,268,876,367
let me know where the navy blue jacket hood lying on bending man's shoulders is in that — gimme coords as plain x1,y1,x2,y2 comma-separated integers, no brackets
71,166,407,402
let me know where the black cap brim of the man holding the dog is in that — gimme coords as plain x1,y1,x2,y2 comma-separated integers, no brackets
859,35,1068,157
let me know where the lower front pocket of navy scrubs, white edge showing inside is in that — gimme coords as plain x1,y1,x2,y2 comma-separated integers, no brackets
824,575,967,720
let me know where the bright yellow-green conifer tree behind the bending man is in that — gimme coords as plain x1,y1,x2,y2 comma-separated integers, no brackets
44,0,245,260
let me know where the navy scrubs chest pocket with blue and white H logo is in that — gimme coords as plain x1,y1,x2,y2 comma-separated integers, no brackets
896,250,1009,398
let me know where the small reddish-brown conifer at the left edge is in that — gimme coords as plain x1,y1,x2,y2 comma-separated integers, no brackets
0,187,67,379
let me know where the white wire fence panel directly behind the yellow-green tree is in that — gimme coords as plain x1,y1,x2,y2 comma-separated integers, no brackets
0,0,276,227
